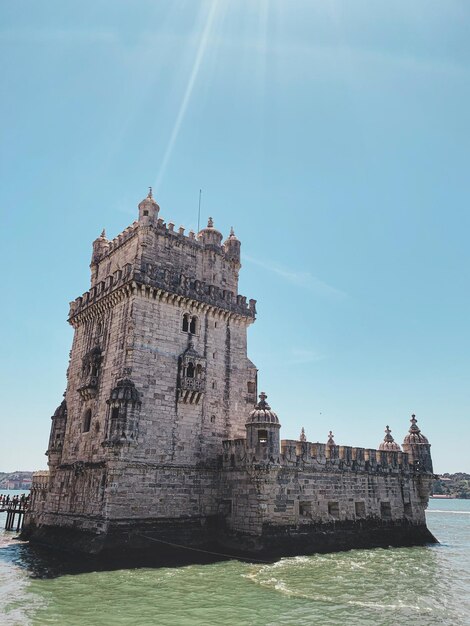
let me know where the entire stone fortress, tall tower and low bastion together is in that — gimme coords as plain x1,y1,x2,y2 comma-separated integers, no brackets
24,192,435,555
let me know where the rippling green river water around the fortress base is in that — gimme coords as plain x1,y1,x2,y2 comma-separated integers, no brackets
0,492,470,626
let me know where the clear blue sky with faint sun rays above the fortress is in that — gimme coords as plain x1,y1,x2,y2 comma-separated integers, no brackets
0,0,470,472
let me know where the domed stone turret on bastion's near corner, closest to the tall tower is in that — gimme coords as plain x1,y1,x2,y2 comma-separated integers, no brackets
245,391,281,463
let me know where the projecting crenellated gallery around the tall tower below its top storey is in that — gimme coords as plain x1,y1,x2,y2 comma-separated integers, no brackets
69,263,256,322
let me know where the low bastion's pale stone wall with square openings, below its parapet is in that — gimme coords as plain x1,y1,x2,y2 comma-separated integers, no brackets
221,467,426,535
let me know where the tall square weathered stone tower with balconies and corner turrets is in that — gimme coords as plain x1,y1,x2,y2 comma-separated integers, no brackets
28,190,257,552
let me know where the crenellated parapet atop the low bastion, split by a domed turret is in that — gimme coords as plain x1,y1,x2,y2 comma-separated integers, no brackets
223,439,413,473
